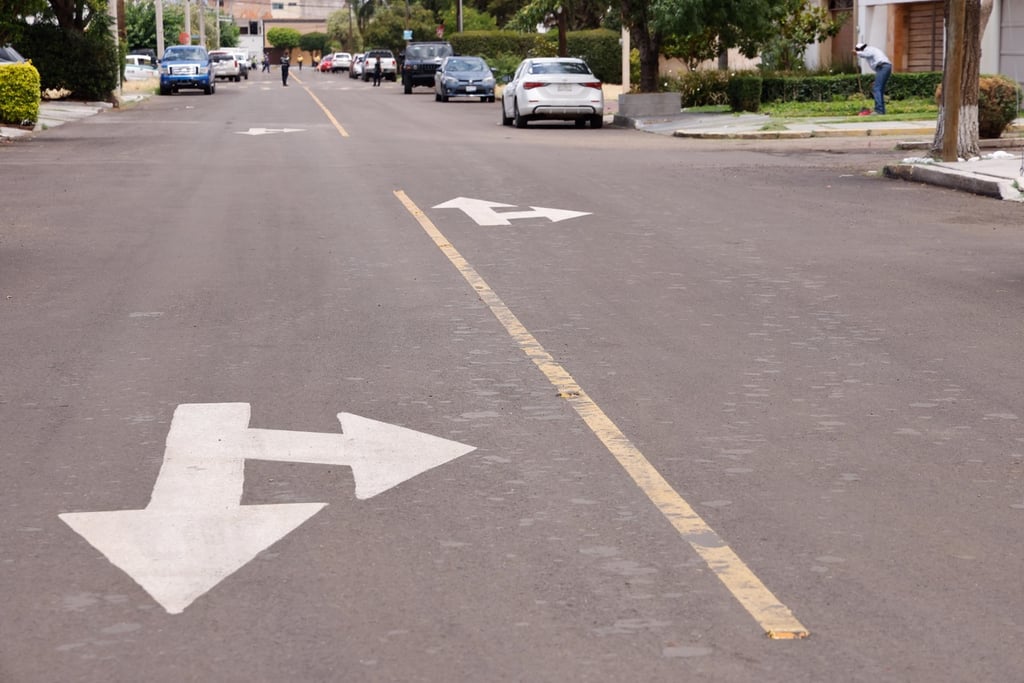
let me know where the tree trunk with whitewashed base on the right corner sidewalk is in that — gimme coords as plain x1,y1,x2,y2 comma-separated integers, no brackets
931,0,992,159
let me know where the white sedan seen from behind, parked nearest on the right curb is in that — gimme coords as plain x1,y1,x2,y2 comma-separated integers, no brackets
502,57,604,128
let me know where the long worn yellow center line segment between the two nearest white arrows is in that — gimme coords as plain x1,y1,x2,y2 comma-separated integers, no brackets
394,189,810,640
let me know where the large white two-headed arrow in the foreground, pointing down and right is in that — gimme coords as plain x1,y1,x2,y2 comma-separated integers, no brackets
59,403,474,614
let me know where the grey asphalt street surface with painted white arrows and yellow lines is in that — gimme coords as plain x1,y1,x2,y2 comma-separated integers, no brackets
0,69,1024,683
